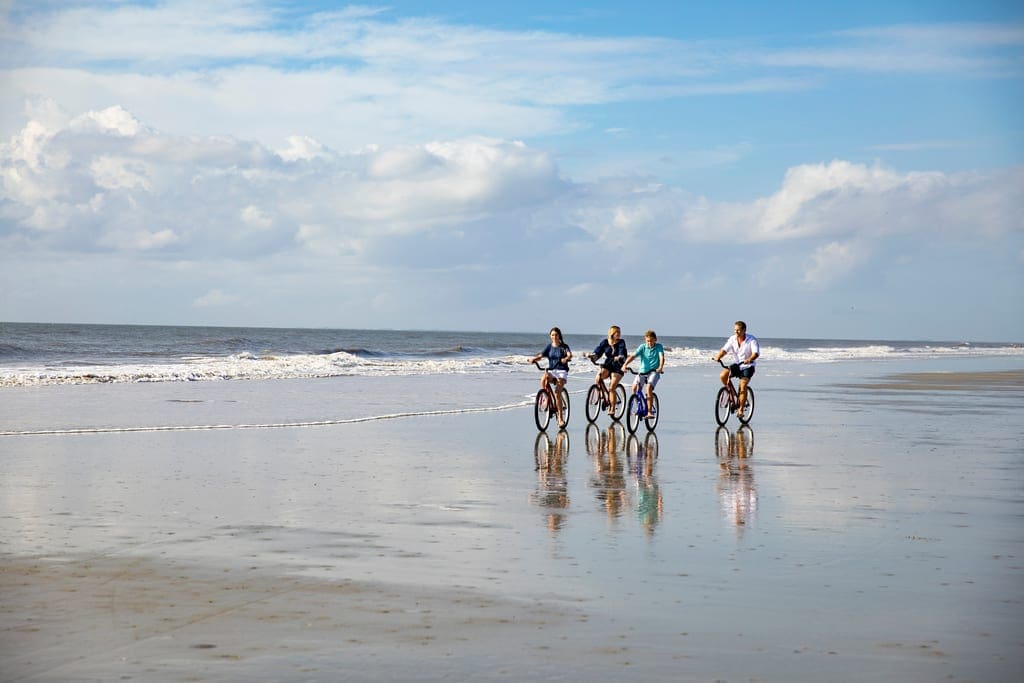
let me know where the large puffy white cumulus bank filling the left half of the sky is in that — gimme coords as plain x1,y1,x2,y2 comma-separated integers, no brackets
0,106,564,258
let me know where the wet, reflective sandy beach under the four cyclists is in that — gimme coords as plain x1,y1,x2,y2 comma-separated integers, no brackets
0,358,1024,682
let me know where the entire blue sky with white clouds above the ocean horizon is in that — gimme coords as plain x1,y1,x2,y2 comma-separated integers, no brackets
0,0,1024,342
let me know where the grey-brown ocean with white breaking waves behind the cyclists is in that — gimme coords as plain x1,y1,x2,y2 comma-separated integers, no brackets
0,323,1024,387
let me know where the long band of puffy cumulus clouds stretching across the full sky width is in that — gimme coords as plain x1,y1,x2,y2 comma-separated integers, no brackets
0,105,1024,301
